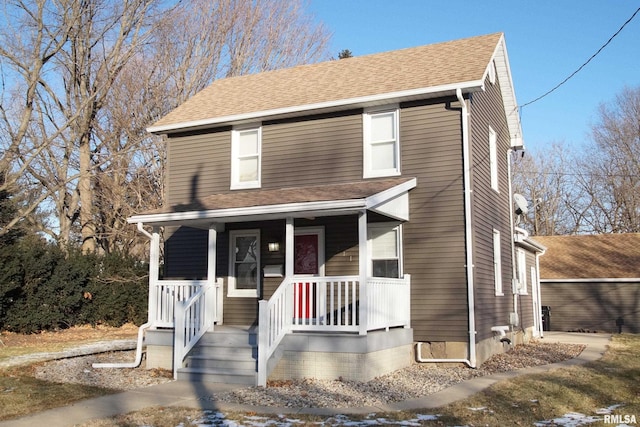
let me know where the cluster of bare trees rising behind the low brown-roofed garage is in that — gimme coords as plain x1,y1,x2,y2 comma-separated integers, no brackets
513,87,640,235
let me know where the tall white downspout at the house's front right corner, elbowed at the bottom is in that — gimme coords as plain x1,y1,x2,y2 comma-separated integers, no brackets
416,88,477,368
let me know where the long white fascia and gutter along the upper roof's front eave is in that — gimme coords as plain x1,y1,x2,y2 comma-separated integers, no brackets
147,80,484,134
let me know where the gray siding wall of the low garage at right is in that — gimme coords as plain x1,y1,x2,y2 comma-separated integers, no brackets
541,280,640,334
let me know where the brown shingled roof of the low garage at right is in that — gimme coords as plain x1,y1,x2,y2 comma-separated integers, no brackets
534,233,640,279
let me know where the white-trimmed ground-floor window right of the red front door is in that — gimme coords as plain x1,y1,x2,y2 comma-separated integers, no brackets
367,223,402,278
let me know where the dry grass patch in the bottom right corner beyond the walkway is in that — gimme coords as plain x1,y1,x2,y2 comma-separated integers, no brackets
425,335,640,426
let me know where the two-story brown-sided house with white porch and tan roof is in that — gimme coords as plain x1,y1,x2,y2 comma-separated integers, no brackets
129,34,542,385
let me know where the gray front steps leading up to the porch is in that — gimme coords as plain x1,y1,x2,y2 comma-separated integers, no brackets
178,326,258,385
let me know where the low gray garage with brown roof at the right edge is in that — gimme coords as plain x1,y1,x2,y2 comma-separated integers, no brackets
535,233,640,333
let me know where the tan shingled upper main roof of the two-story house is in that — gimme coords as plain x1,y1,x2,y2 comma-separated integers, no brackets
150,33,502,129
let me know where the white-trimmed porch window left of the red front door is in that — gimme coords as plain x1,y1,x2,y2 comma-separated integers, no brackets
228,230,260,298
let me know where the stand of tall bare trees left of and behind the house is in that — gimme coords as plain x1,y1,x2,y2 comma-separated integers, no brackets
0,0,328,252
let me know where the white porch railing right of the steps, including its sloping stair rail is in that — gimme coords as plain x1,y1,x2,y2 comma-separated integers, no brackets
258,275,411,386
